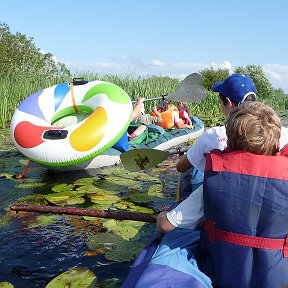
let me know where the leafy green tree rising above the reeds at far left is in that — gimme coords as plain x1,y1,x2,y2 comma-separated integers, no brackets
0,22,70,77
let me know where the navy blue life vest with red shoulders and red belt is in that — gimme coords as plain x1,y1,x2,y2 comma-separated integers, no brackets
198,145,288,288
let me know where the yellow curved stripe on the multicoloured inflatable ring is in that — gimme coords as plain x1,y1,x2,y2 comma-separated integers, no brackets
69,107,108,152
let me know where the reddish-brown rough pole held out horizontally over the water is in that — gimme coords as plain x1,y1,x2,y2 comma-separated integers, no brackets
10,204,157,223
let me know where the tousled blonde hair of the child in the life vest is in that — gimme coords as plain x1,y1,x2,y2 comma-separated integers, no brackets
226,102,281,155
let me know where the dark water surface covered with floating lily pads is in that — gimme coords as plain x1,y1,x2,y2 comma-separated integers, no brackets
0,129,179,288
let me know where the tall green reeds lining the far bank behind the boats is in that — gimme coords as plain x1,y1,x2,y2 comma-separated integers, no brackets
0,72,288,128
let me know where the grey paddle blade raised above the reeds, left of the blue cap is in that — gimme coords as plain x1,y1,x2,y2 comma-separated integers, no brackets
166,73,206,102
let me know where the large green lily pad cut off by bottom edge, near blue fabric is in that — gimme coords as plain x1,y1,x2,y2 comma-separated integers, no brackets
45,268,99,288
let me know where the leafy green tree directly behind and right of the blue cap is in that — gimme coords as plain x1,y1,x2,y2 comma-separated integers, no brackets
235,64,273,100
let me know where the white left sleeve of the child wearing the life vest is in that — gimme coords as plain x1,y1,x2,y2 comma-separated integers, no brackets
166,185,204,229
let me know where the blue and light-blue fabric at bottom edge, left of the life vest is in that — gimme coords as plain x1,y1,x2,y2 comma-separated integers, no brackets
122,228,212,288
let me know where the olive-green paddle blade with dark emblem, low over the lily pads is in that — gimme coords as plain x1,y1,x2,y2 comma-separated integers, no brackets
120,148,170,172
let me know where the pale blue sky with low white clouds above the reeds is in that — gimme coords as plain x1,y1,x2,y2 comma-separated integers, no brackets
0,0,288,93
